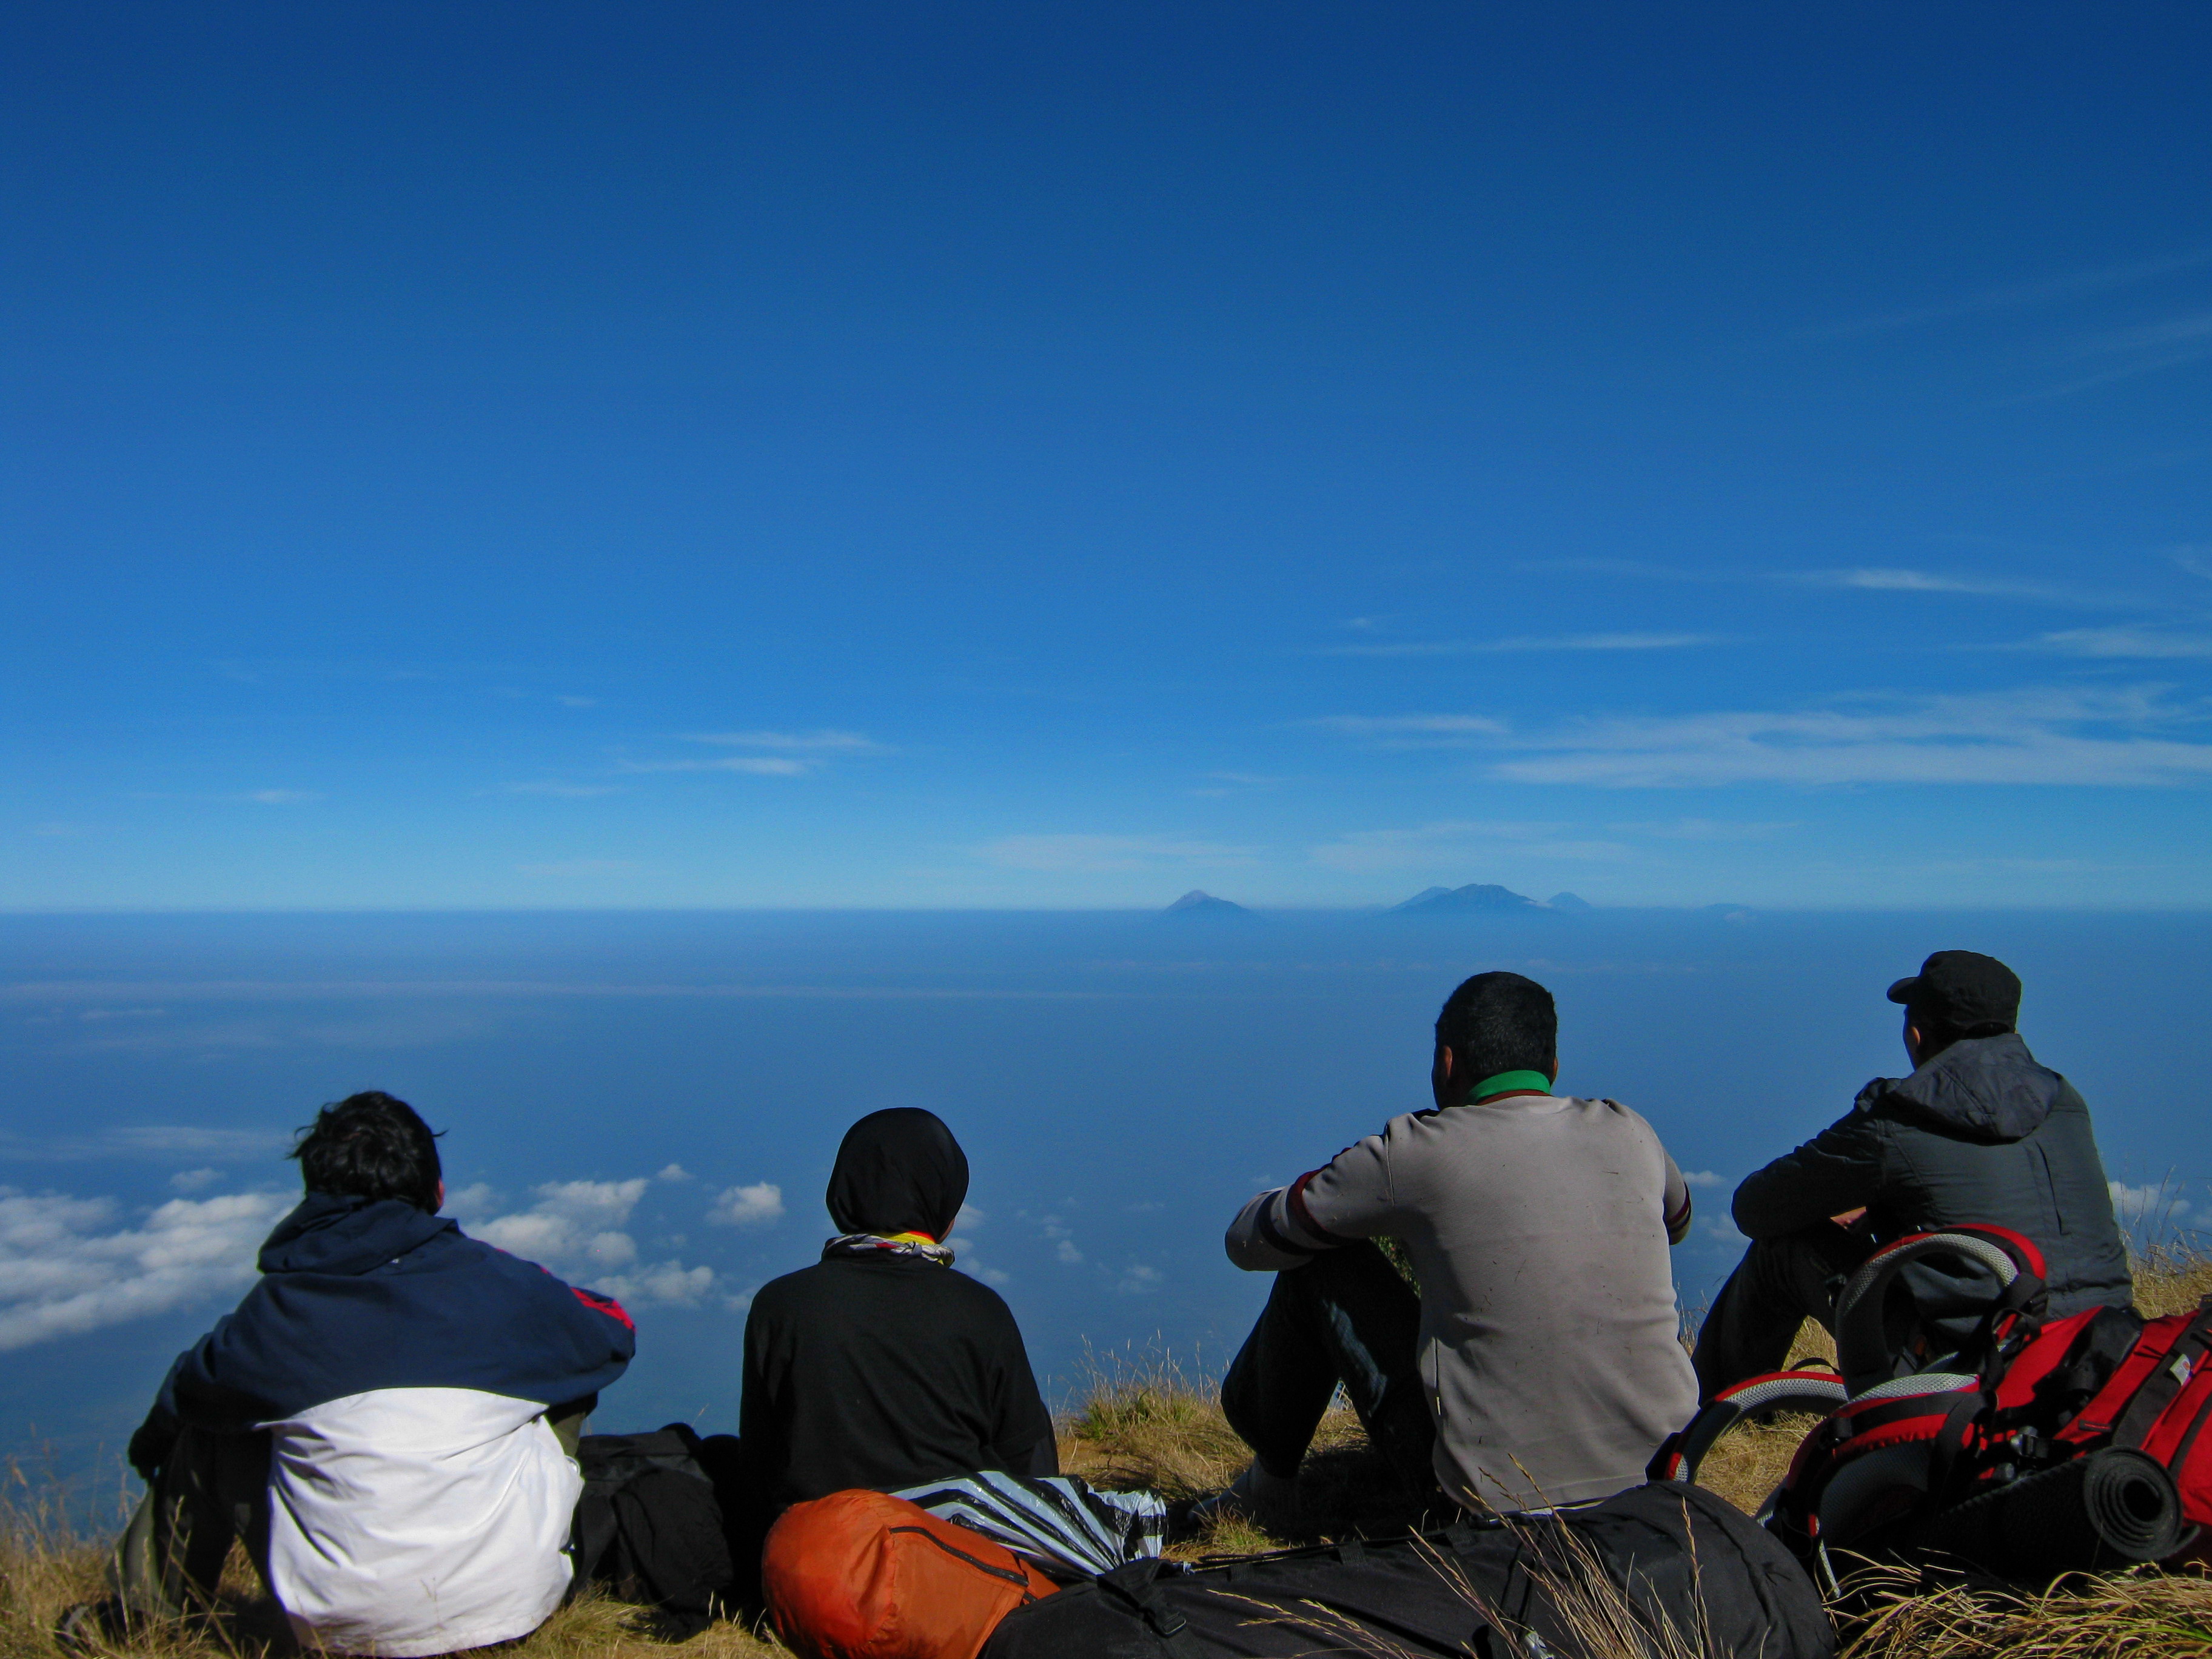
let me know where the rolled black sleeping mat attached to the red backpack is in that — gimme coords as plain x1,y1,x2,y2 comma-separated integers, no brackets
1911,1447,2188,1577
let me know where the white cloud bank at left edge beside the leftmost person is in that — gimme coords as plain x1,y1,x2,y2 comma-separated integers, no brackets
0,1188,298,1349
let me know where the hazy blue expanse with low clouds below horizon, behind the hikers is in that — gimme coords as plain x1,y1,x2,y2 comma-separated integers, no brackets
0,909,2212,1495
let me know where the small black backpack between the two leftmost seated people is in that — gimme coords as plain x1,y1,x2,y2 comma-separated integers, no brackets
571,1423,737,1641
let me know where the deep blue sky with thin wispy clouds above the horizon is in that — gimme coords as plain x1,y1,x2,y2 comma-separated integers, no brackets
0,0,2212,907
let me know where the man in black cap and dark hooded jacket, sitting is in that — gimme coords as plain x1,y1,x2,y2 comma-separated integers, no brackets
1697,951,2134,1400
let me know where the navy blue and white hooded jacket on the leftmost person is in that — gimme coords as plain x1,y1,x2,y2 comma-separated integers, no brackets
148,1192,637,1659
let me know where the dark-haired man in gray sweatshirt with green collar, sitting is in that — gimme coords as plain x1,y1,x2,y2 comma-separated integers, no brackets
1199,973,1697,1533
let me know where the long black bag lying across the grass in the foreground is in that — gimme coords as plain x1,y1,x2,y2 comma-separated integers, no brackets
982,1484,1836,1659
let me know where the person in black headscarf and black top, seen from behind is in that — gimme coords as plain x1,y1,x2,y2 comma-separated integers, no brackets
739,1106,1059,1509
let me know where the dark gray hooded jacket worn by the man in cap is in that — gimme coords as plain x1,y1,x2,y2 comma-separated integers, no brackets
1734,1031,2134,1316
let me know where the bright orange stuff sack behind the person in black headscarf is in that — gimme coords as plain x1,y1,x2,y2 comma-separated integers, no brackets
761,1491,1059,1659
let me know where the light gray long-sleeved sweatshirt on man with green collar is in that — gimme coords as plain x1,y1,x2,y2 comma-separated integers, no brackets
1228,1095,1697,1509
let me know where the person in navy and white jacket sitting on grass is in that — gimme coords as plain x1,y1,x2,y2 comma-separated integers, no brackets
78,1093,637,1659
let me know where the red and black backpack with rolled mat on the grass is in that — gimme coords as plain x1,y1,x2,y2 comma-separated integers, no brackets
1650,1225,2212,1586
